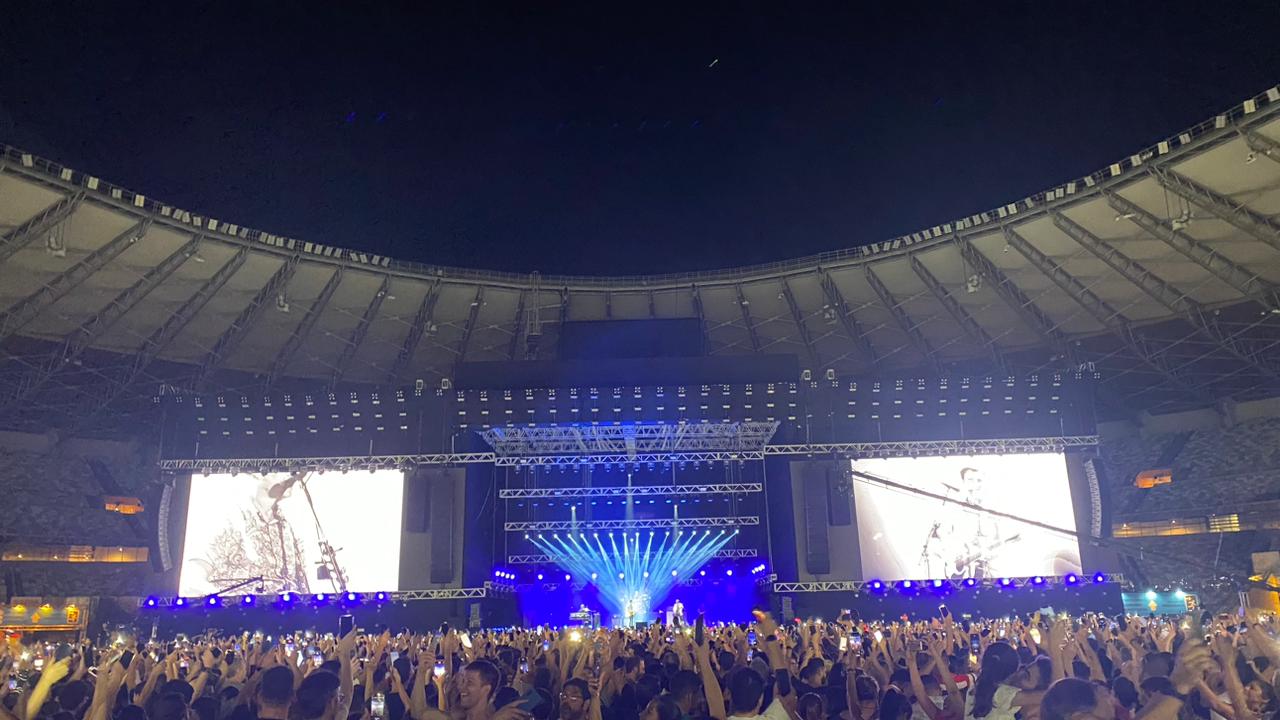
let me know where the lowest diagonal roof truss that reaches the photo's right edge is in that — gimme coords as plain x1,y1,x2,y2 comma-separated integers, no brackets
1051,211,1280,378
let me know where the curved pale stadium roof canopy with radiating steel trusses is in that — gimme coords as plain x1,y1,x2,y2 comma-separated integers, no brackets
0,83,1280,430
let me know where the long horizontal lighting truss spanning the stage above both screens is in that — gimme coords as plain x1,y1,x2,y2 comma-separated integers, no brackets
159,423,1098,473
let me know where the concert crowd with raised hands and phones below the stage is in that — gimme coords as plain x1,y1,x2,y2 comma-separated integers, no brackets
0,607,1280,720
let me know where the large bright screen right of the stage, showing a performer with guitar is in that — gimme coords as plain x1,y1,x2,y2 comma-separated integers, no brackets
852,452,1080,579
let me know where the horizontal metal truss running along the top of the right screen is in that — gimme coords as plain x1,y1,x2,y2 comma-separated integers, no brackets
764,436,1098,457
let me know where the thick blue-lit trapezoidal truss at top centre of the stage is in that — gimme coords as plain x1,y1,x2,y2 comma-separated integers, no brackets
481,420,778,457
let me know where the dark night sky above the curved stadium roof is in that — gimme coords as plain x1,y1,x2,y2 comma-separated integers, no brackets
0,0,1280,274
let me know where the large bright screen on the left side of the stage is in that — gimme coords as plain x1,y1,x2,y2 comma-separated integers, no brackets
178,470,404,596
